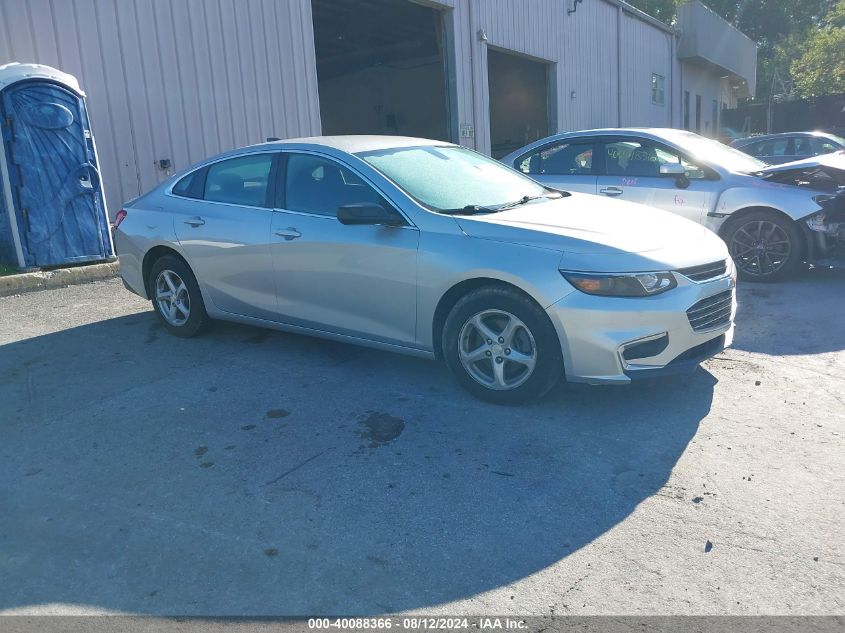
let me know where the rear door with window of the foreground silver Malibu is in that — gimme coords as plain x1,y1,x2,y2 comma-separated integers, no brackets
169,152,278,319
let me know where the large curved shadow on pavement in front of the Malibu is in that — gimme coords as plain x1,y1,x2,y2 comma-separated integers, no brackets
0,312,712,615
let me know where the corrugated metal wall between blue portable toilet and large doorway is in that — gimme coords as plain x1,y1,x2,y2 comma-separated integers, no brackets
0,0,320,216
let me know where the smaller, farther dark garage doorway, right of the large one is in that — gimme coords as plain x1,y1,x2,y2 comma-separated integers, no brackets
487,49,550,158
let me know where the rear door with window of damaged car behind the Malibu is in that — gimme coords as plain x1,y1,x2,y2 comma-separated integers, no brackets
513,138,596,194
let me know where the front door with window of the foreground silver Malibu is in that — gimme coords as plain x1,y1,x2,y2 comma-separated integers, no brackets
271,153,419,346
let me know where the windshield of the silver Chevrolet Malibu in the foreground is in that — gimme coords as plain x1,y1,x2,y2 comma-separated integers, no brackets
357,145,548,211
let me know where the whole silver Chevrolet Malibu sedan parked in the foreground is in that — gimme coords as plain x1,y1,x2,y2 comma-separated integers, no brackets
115,136,736,404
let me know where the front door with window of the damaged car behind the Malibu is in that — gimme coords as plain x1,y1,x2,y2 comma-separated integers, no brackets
597,137,719,223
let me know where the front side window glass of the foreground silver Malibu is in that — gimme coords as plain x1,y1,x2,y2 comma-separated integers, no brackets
285,154,387,217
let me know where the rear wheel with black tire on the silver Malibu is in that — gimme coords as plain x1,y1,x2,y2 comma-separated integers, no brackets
148,255,211,338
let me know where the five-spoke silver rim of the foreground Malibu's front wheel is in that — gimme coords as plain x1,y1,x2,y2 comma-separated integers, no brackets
458,310,537,391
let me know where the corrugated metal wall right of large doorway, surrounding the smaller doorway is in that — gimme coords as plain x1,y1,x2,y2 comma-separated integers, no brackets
436,0,680,152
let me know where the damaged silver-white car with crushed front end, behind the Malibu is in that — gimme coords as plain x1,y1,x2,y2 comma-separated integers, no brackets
501,128,845,281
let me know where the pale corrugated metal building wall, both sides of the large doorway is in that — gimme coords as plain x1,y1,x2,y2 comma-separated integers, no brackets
0,0,716,215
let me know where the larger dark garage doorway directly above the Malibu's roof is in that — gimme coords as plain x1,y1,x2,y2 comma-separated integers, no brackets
311,0,450,140
